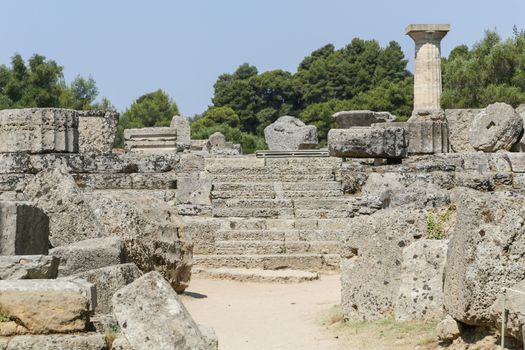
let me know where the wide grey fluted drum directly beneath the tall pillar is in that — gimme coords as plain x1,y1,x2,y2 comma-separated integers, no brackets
396,121,449,154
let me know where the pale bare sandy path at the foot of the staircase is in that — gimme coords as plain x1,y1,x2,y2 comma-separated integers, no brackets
182,275,348,350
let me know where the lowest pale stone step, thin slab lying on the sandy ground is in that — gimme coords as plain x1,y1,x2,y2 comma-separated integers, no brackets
191,266,319,283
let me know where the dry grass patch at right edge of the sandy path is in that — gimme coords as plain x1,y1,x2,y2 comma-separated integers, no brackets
320,305,436,350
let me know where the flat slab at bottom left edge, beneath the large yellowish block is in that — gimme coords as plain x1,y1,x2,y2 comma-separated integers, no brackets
5,333,107,350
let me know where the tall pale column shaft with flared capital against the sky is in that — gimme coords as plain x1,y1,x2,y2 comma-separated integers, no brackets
405,24,450,115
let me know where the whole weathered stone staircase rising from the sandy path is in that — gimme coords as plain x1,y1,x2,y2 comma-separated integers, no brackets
190,157,356,272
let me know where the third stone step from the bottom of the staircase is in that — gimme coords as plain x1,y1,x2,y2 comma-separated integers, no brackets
215,240,339,255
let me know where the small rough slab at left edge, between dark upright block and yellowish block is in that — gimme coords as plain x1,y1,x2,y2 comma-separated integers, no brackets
0,255,60,280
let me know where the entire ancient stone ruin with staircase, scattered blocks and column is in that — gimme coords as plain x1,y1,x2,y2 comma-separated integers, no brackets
0,25,525,350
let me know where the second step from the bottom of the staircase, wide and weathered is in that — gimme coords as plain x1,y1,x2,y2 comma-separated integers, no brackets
193,254,340,271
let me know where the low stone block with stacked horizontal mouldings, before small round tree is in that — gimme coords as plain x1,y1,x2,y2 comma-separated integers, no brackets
124,127,178,152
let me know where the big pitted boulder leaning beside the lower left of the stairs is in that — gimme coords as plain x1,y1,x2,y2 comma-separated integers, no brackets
89,192,193,292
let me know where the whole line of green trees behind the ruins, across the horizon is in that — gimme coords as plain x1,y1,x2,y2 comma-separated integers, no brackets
0,27,525,153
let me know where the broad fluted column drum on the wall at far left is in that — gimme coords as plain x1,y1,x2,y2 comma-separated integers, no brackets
0,108,78,153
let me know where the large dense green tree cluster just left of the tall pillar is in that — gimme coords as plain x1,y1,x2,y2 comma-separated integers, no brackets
205,38,413,142
